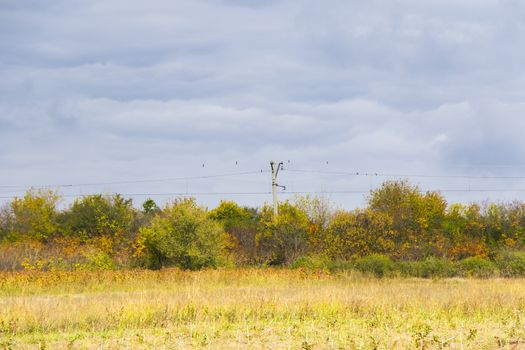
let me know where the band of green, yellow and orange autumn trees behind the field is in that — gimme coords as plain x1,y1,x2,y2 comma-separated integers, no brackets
0,181,525,273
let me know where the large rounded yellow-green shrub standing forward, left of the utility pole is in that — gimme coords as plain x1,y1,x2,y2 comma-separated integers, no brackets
135,199,222,269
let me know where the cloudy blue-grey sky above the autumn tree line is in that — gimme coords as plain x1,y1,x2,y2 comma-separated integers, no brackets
0,0,525,208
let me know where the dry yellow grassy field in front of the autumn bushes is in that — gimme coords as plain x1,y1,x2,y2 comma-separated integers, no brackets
0,269,525,349
